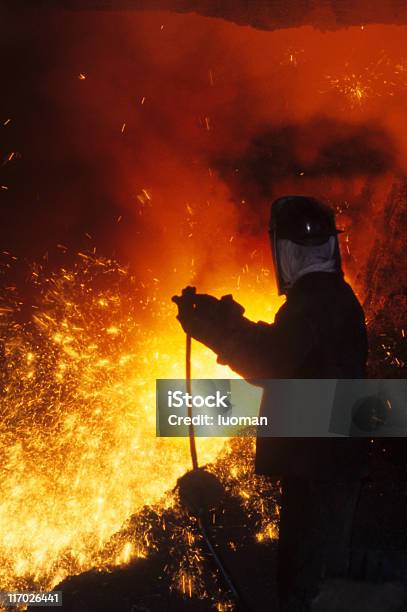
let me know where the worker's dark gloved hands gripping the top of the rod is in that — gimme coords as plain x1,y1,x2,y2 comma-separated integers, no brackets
172,287,244,352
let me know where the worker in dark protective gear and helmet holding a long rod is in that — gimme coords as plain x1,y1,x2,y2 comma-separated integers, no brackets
174,196,368,612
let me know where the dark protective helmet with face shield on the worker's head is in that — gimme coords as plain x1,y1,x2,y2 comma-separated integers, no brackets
269,196,342,295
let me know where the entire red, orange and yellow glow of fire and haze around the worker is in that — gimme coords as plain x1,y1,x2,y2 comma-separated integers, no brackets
0,11,407,597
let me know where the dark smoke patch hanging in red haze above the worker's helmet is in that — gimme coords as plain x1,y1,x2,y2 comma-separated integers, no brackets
215,117,398,202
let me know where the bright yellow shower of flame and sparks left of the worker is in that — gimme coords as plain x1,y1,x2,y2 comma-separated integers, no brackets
0,253,278,596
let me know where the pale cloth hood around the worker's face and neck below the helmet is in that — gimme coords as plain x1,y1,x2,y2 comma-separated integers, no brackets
276,236,340,293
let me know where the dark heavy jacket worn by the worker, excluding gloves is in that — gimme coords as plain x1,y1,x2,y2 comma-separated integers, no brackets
217,272,369,480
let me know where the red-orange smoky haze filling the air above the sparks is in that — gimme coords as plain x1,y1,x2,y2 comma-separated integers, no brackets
0,10,407,290
